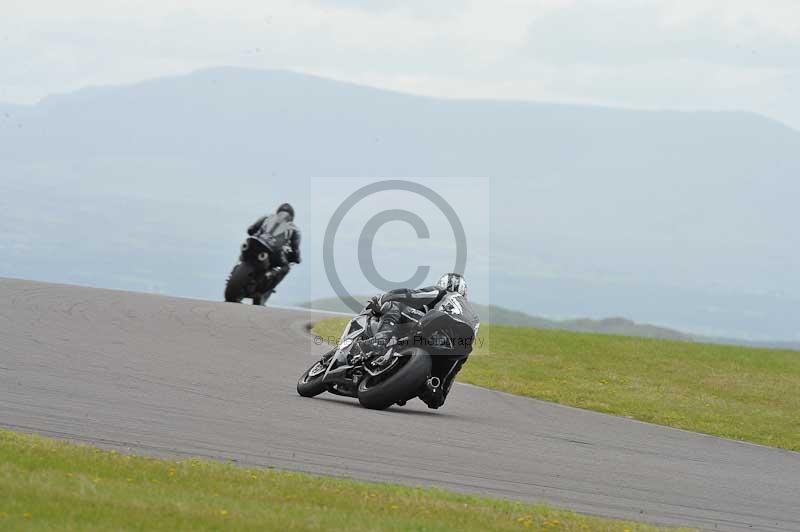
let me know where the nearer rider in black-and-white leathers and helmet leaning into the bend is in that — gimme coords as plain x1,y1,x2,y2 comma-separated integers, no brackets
361,273,477,408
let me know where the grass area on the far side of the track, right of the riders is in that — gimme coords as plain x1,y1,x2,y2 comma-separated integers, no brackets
314,318,800,451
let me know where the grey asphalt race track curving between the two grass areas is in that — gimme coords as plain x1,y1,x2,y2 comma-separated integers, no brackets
0,279,800,531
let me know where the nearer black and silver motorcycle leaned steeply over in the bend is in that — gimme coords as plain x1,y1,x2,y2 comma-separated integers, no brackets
297,294,477,410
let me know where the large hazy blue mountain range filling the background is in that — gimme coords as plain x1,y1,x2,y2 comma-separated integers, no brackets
0,68,800,342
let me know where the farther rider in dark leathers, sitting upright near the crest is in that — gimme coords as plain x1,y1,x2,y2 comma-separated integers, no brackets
247,203,300,299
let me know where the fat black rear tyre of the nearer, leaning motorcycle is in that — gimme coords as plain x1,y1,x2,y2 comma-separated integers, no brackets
358,348,431,410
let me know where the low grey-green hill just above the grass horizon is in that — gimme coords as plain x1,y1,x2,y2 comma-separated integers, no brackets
300,296,693,341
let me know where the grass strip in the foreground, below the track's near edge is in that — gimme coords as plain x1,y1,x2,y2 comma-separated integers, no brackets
0,430,684,532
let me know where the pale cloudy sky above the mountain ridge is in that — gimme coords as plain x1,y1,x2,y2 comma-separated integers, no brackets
0,0,800,129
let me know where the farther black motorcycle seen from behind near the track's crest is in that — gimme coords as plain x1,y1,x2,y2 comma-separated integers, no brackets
225,236,280,305
